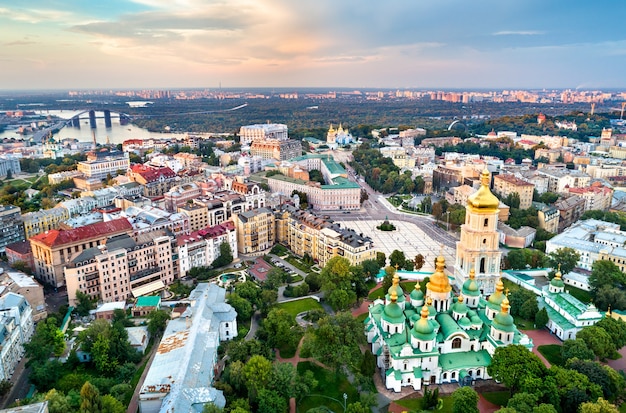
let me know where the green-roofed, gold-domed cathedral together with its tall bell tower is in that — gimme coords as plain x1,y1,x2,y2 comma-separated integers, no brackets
365,171,533,392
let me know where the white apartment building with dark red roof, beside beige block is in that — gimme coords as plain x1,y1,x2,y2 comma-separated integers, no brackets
176,221,238,278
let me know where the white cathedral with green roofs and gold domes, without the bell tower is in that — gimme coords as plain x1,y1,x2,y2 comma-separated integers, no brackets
365,260,533,392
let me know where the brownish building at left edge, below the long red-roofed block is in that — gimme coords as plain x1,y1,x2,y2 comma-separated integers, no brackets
0,270,48,323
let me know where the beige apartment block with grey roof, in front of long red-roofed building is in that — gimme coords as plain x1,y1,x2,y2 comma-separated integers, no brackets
64,231,177,305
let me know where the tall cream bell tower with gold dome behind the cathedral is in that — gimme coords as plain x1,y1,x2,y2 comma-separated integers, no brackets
454,170,502,295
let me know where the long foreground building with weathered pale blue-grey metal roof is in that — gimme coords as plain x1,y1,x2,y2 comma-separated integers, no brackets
139,283,237,413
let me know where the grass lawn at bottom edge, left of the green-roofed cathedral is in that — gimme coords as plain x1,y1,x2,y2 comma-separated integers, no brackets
297,361,359,413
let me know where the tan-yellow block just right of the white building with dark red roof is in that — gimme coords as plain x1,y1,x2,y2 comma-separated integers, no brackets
234,208,276,254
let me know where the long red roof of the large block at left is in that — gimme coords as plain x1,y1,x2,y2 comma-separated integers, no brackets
30,218,133,247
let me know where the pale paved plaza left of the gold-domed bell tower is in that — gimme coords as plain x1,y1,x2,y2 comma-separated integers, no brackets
341,220,456,273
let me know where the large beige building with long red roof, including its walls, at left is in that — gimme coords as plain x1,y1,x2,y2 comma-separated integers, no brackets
29,218,133,287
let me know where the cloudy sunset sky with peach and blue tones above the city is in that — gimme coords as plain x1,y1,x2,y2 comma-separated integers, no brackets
0,0,626,90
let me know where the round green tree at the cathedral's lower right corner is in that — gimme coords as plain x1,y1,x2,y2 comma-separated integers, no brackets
487,345,545,396
